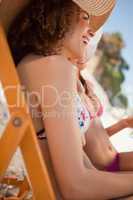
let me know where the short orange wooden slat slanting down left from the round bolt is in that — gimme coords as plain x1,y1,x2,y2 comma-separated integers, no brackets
0,113,28,177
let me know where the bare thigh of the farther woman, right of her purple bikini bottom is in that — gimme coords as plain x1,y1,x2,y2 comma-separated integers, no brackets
119,152,133,171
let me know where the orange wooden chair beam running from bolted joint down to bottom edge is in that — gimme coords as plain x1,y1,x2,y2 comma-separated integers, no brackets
20,127,55,200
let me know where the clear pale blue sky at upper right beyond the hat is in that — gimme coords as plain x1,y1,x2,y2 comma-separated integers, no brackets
104,0,133,105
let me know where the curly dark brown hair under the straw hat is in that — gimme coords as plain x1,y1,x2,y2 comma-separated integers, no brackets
8,0,80,65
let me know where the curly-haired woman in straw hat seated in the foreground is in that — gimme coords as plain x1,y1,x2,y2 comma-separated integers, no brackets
8,0,133,200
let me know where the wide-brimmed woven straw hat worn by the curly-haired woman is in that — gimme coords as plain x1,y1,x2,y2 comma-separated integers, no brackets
72,0,116,32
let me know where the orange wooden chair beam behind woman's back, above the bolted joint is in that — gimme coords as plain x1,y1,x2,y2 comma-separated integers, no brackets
0,26,24,111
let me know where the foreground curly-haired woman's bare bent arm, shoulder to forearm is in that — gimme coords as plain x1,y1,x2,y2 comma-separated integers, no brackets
18,57,133,200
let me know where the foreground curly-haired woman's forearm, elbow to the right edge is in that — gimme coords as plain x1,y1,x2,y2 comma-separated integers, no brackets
70,170,133,200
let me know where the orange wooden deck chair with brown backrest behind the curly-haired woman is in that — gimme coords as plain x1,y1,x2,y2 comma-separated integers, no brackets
0,0,58,200
